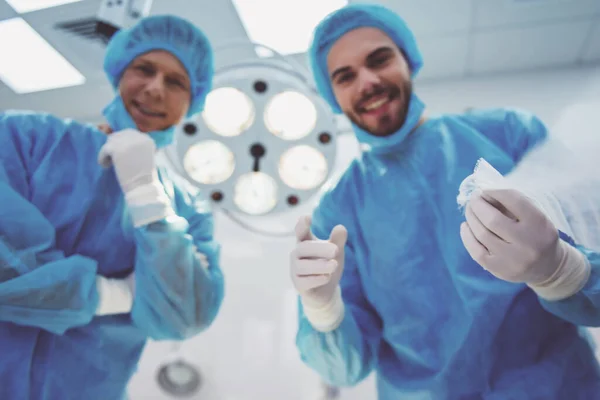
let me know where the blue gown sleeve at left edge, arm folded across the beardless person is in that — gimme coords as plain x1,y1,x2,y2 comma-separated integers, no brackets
0,113,99,334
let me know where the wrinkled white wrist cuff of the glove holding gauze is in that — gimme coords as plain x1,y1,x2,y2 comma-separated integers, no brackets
529,240,591,301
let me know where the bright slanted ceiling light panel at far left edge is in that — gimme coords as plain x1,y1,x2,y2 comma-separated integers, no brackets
0,18,85,94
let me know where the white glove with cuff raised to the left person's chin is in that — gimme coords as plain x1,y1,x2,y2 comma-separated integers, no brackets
98,129,175,227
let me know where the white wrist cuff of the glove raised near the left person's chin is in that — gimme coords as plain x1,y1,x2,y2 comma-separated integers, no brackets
125,182,175,228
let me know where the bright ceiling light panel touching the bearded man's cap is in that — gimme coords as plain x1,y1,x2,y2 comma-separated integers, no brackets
232,0,348,55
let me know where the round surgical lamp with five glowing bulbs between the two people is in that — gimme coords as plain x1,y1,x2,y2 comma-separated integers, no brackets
165,42,337,222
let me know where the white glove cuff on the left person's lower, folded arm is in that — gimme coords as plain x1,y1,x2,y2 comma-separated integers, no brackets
96,273,135,316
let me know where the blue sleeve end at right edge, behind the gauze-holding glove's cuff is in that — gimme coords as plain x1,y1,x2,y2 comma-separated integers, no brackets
540,247,600,327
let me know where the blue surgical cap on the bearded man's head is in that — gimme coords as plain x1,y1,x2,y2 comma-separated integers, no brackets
308,4,423,113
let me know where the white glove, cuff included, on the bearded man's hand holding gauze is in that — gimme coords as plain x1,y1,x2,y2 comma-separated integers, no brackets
460,189,590,300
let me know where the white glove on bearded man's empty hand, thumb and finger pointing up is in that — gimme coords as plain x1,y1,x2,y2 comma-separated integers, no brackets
290,217,348,332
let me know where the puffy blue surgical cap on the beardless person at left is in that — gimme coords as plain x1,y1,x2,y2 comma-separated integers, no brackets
104,15,214,116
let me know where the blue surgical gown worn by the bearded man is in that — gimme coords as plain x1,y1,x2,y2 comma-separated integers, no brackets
297,109,600,400
